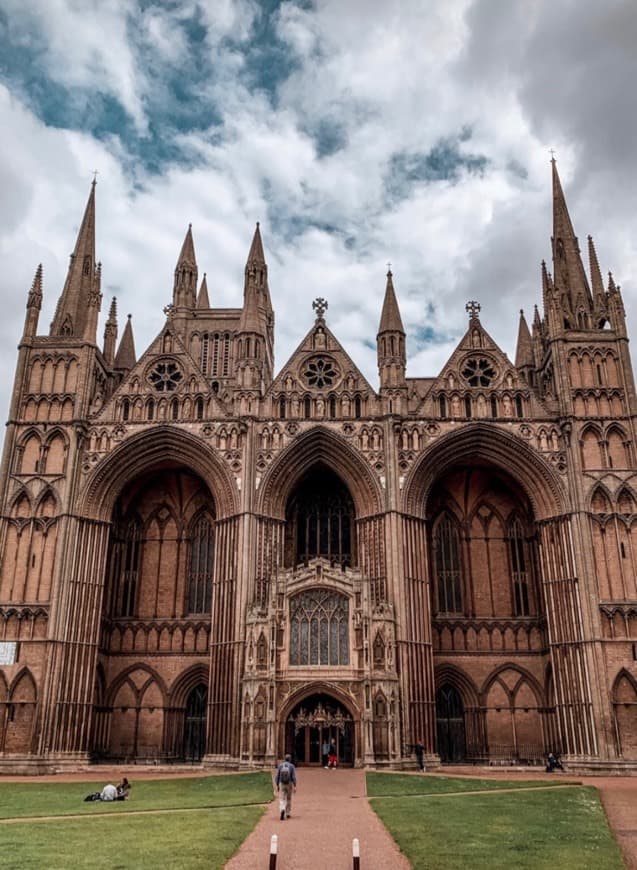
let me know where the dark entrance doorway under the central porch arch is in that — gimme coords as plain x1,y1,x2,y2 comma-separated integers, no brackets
285,694,355,767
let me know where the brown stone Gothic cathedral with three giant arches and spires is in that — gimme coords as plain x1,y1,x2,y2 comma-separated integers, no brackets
0,161,637,773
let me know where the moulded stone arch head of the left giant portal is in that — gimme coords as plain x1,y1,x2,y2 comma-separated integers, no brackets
79,426,239,521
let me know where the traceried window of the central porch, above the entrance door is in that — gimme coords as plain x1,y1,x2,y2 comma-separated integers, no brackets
290,589,349,666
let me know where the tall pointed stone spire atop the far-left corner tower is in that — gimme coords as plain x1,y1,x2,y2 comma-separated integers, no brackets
50,179,101,341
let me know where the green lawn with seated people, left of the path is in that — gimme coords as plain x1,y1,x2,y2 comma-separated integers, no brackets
0,772,272,870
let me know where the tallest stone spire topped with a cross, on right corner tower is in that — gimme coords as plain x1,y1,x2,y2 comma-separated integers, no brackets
551,158,593,313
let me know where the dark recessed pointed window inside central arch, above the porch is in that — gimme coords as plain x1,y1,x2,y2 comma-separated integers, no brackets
285,467,354,567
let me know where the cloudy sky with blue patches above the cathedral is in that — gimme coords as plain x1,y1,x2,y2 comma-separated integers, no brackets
0,0,637,430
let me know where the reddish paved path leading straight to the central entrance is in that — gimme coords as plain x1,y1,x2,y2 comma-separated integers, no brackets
226,768,411,870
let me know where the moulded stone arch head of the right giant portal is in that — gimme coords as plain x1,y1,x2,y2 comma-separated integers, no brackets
403,423,565,520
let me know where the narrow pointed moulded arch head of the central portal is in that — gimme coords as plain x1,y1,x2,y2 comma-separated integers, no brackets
257,426,382,519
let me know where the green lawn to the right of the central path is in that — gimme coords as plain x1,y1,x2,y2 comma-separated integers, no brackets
367,774,624,870
